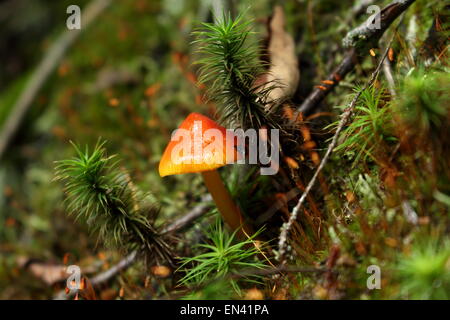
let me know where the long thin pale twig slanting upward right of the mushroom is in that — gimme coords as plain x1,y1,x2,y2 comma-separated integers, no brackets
277,32,400,265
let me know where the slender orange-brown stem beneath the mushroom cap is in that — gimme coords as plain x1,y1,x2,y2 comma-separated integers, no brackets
202,170,253,236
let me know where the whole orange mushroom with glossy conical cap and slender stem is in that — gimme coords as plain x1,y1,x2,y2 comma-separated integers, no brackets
159,113,252,235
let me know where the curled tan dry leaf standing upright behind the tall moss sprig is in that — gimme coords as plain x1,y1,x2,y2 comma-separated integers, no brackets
256,6,300,107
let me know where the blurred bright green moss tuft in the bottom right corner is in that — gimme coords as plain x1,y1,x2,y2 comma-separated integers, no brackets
395,239,450,300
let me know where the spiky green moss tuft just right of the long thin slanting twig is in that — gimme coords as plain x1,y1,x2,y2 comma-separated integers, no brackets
331,87,395,164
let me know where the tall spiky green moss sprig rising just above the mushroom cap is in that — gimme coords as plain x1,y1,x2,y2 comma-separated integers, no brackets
194,15,278,129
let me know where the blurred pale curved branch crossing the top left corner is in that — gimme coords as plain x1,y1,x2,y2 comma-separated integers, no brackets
0,0,111,160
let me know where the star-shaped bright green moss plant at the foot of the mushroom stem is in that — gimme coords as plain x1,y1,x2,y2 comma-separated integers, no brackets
178,220,267,294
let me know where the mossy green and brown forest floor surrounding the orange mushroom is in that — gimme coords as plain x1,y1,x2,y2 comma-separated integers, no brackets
0,0,450,299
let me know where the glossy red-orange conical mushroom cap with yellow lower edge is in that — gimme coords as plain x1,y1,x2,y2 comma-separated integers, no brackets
159,112,238,177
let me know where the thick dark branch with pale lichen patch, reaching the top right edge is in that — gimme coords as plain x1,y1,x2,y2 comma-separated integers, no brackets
293,0,415,119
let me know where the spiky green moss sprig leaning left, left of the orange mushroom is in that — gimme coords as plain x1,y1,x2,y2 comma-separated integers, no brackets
52,142,171,261
